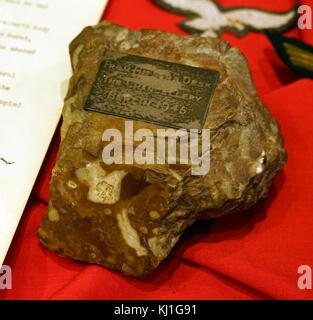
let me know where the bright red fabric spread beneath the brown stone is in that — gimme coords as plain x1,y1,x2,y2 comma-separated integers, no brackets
0,0,313,299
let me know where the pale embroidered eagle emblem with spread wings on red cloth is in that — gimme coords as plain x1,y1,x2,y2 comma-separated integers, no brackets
153,0,297,37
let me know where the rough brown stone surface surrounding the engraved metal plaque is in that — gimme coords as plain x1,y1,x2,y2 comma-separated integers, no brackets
38,22,286,276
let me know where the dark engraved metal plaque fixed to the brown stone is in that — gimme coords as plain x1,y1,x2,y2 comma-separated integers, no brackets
84,52,219,132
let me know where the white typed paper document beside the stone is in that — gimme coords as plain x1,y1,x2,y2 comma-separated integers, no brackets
0,0,107,266
